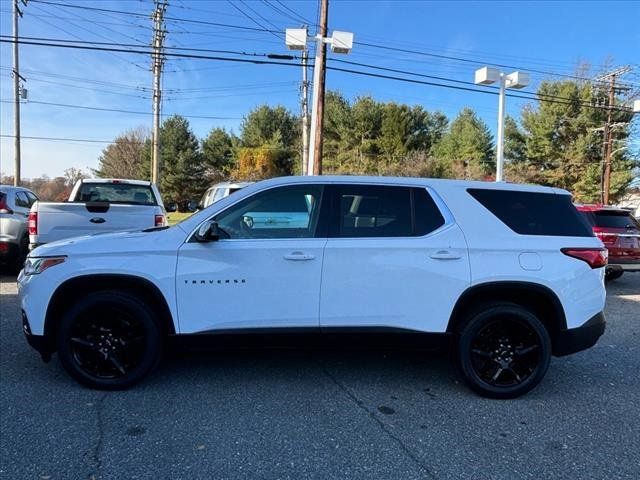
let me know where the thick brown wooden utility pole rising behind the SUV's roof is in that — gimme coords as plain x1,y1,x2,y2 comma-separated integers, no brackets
308,0,329,175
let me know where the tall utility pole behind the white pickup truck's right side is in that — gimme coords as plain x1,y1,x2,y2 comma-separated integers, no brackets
151,0,167,184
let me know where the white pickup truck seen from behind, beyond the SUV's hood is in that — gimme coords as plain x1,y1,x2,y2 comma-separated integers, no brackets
29,179,167,250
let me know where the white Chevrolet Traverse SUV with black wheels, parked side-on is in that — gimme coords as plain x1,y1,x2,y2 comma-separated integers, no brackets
18,177,607,398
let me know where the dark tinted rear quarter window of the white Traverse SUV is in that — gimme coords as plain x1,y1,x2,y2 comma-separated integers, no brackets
467,188,593,237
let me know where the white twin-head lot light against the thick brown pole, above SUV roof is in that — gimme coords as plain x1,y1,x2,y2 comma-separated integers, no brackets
285,28,353,175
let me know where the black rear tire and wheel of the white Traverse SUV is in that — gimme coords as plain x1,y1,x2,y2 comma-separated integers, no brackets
456,303,551,399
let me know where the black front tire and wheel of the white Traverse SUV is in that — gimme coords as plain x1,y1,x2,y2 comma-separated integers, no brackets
57,291,163,390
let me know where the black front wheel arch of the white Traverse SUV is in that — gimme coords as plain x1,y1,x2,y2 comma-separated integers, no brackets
44,274,176,349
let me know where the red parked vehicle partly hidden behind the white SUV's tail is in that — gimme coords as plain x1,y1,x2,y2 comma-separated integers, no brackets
576,205,640,280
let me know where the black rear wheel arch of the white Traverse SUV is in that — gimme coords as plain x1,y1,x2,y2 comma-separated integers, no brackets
447,281,567,342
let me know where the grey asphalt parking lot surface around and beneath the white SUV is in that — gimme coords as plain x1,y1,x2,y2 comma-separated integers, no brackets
0,274,640,480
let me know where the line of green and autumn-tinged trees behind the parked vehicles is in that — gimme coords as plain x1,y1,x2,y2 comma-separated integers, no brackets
86,81,640,205
